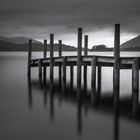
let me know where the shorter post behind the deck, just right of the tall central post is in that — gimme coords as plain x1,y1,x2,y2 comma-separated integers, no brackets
84,35,88,92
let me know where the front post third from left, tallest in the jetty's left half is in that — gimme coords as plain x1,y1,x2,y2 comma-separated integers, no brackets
50,34,54,81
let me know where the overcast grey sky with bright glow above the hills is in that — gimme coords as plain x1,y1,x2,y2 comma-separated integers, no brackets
0,0,140,48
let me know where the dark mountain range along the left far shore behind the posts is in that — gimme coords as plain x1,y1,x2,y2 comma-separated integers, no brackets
0,37,77,51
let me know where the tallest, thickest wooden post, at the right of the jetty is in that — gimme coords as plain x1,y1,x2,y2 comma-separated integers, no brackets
113,24,120,107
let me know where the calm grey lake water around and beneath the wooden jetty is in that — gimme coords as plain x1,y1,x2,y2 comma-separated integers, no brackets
0,52,140,140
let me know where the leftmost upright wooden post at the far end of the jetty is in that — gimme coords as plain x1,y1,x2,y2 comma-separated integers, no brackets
27,39,32,75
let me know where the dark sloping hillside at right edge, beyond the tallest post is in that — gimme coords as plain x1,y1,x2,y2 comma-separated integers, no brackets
121,35,140,51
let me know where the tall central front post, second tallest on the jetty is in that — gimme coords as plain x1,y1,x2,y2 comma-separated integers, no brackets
77,28,82,95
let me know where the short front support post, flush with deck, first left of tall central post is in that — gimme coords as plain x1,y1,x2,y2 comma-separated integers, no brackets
62,57,67,94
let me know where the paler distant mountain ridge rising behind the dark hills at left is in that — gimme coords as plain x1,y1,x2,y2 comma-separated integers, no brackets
0,37,42,44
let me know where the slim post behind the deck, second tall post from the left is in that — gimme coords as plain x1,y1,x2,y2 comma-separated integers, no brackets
43,40,47,84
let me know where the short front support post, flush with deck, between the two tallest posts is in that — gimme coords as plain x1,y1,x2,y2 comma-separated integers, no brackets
91,56,97,102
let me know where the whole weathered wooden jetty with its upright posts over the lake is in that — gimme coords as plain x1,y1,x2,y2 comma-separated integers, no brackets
28,24,140,114
